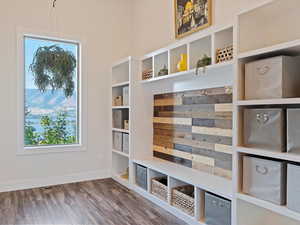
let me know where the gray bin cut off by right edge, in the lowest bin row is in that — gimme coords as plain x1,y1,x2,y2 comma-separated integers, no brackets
287,164,300,213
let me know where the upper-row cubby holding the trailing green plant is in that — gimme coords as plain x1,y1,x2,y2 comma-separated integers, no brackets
189,36,212,69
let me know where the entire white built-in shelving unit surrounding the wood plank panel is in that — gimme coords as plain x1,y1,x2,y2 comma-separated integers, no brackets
112,1,300,225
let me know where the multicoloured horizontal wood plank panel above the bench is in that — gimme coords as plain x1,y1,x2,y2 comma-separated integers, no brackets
153,87,232,179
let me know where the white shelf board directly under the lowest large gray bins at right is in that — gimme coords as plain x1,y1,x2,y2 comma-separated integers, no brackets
237,193,300,221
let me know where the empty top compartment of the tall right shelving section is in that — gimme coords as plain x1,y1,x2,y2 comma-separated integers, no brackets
238,1,300,54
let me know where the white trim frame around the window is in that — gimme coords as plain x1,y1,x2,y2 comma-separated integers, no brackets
16,28,88,155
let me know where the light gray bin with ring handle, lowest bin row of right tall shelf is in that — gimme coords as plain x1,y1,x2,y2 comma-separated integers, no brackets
243,156,287,205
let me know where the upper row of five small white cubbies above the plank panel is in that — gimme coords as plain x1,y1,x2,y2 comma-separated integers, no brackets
140,26,234,83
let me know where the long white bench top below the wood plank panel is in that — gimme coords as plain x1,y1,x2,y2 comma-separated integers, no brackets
133,158,232,200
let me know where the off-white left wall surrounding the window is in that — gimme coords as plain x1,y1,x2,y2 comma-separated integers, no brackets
0,0,131,191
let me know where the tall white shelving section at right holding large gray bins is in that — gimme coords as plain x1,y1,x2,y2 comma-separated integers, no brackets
234,1,300,225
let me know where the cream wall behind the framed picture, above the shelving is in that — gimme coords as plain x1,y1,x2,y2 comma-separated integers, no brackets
132,0,266,56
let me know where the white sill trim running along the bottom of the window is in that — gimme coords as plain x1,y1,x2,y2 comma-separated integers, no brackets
17,144,86,156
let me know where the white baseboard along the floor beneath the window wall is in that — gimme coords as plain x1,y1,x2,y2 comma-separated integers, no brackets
0,170,111,193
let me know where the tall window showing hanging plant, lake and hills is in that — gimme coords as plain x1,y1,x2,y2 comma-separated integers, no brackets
24,36,80,148
